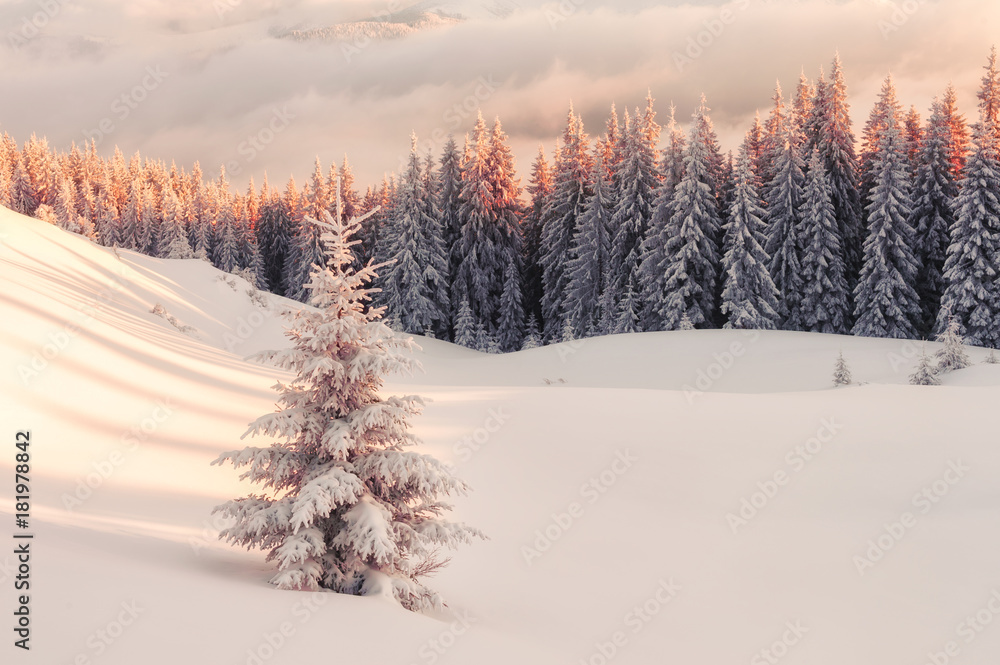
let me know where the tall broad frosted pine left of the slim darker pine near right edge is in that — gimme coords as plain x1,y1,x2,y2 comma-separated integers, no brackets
853,81,920,339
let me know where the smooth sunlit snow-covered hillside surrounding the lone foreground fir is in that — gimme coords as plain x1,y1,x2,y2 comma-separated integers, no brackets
0,209,1000,665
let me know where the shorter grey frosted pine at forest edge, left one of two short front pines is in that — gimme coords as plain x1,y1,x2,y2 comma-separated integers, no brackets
722,145,778,330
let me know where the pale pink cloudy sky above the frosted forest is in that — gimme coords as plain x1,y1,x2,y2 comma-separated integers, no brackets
0,0,1000,186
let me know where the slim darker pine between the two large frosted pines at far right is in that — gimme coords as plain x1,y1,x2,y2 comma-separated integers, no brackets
910,99,958,335
